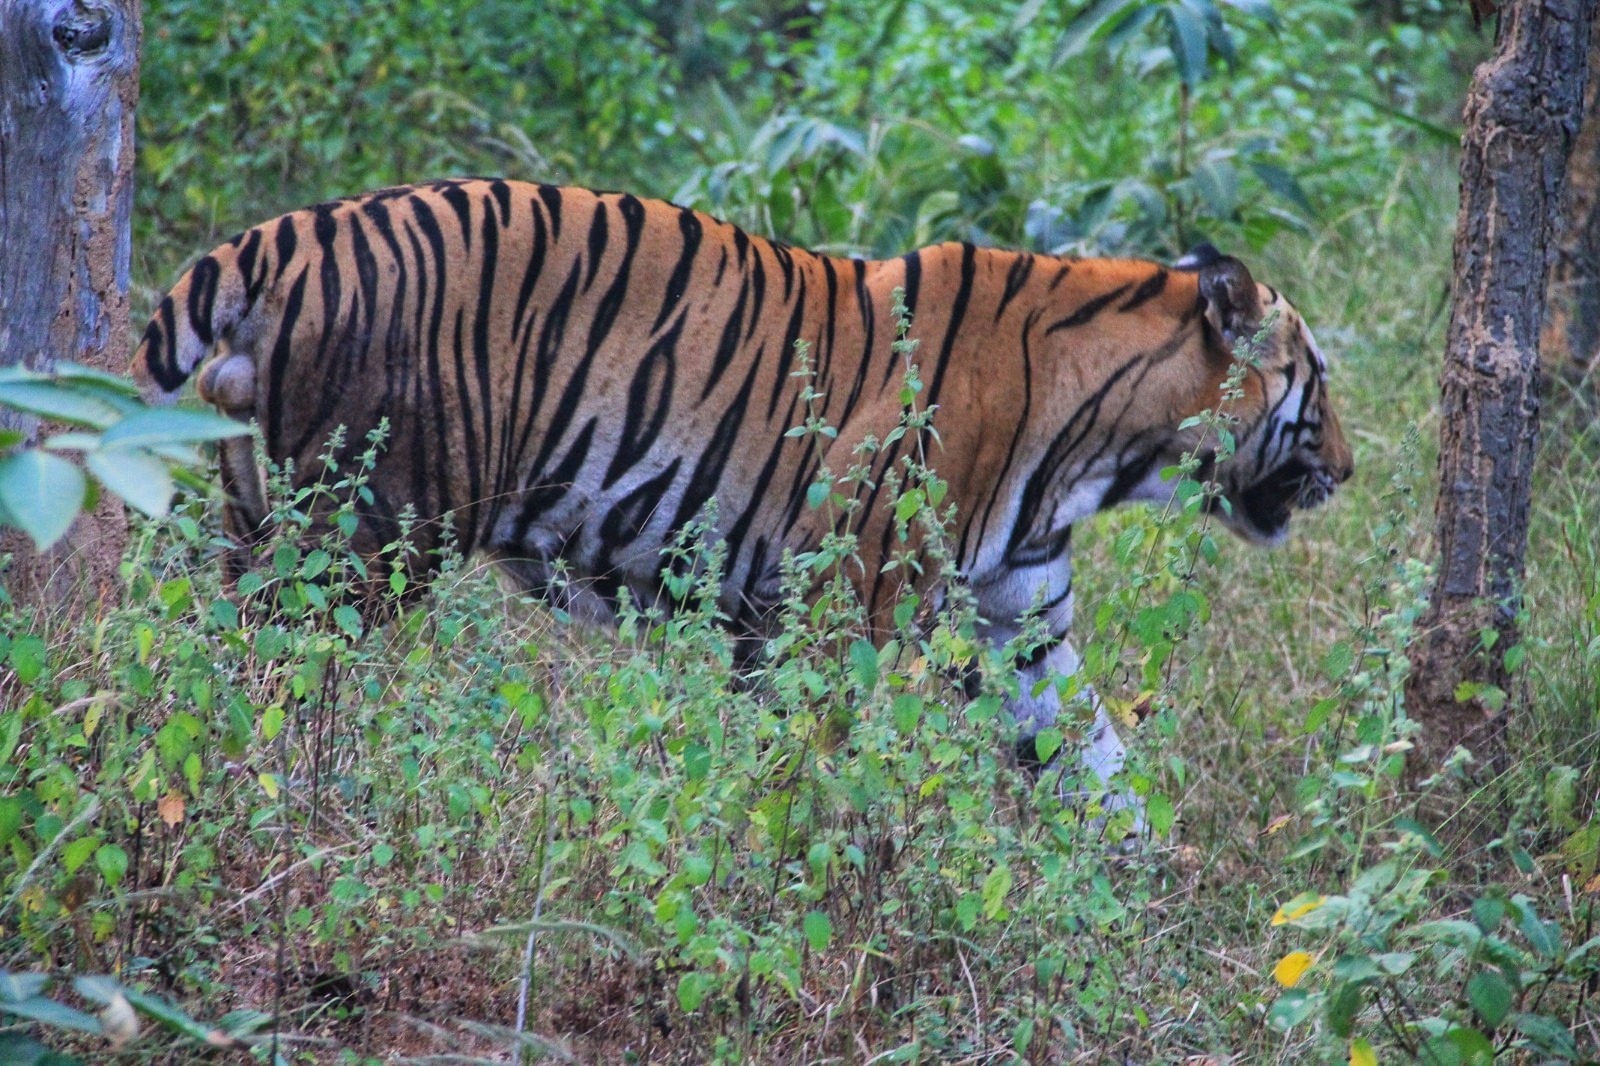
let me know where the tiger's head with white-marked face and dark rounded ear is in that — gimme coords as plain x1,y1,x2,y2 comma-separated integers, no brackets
1173,245,1354,544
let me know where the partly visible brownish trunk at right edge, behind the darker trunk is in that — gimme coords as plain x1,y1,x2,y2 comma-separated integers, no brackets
1541,19,1600,378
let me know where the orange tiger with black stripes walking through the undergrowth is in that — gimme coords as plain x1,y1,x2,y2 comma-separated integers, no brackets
133,178,1354,807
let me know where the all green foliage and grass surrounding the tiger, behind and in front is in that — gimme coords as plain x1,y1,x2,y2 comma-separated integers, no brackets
0,0,1600,1064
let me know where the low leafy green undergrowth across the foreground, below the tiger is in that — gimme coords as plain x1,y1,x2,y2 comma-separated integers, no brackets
9,256,1600,1063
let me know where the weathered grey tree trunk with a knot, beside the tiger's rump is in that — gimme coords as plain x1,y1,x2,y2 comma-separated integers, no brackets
0,0,139,607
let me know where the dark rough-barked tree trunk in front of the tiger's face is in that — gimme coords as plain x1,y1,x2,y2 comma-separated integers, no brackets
1406,0,1595,775
